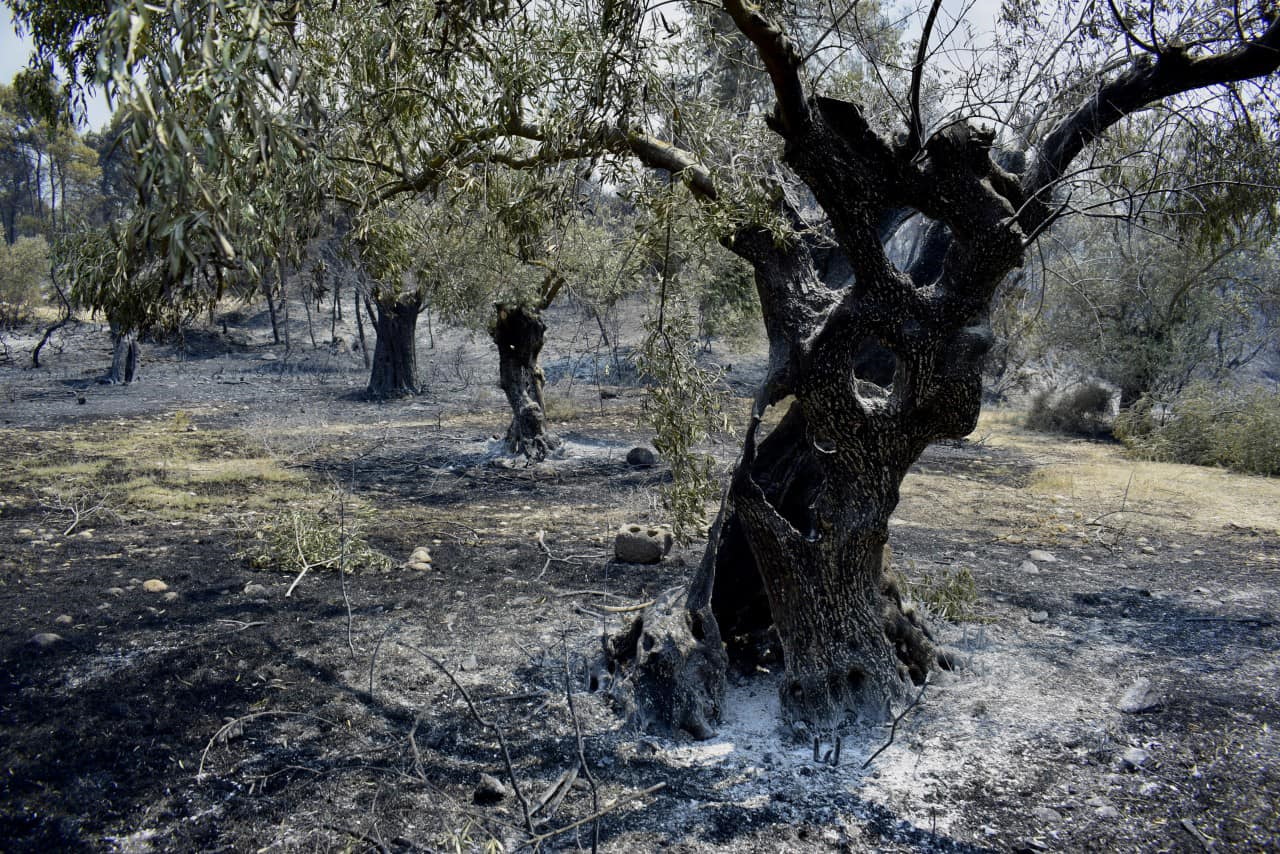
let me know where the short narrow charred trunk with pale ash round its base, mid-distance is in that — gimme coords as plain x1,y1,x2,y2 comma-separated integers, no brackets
489,302,561,460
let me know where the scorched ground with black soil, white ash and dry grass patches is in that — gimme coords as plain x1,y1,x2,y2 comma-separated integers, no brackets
0,313,1280,851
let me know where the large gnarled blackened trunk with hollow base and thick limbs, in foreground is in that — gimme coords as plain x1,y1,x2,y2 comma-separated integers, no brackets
609,0,1280,736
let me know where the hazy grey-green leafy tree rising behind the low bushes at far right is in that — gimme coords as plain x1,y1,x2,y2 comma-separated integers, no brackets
1033,220,1280,408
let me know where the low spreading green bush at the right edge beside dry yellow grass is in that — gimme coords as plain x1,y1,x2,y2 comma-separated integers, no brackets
1114,383,1280,475
